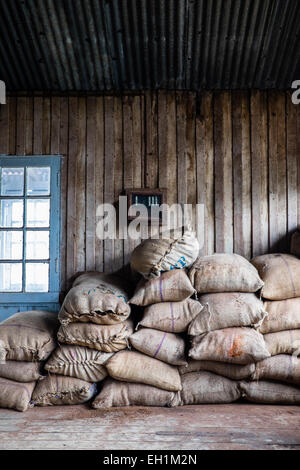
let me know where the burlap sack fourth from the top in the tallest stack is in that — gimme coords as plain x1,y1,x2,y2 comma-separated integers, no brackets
129,328,187,366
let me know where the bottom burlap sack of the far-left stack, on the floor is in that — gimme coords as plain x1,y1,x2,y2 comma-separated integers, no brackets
0,377,35,411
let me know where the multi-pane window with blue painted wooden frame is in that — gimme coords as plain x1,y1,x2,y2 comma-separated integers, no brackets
0,155,61,321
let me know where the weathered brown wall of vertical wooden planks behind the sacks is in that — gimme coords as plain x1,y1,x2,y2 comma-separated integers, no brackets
0,91,300,289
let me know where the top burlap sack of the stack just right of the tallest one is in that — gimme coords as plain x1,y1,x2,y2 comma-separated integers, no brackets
189,253,263,294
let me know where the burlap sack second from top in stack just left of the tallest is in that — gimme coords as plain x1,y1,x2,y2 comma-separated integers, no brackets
57,320,133,353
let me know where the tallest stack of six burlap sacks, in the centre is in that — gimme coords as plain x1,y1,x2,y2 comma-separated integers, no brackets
92,232,202,408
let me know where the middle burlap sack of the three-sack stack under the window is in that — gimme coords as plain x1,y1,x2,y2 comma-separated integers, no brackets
0,361,44,383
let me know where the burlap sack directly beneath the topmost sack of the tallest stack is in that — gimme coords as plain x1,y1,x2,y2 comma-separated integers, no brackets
129,269,195,306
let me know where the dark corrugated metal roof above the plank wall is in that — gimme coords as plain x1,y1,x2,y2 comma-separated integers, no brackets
0,0,300,91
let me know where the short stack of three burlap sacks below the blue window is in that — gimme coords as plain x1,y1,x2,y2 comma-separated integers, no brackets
0,310,59,411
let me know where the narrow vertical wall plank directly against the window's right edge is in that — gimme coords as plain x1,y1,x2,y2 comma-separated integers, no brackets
58,97,69,292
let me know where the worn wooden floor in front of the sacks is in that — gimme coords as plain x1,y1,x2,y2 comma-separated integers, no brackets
0,404,300,450
